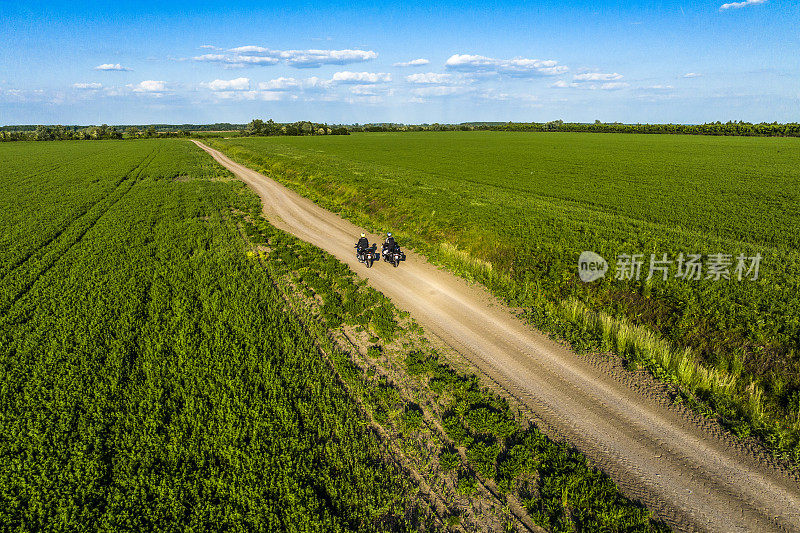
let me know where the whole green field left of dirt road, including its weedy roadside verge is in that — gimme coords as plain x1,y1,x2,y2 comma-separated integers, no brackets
0,139,665,531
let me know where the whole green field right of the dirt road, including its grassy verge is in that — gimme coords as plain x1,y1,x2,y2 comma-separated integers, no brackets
209,132,800,460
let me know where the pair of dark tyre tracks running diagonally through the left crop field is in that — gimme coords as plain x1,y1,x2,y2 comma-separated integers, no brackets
0,149,158,321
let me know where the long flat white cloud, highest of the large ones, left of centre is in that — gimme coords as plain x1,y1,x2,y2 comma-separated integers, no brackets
192,45,378,68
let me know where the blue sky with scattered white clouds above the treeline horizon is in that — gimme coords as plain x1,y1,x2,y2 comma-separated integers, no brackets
0,0,800,124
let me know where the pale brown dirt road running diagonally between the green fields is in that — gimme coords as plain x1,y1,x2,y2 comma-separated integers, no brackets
195,141,800,533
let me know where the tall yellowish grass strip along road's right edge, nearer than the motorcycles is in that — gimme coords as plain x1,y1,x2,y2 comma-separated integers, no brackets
429,243,800,464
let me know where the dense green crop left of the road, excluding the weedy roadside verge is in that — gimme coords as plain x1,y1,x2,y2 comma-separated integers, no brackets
0,140,438,531
